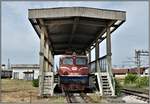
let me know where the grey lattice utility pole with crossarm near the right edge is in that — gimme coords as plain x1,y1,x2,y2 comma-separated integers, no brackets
135,50,149,76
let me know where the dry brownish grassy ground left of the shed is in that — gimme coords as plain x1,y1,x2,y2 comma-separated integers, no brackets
1,79,65,104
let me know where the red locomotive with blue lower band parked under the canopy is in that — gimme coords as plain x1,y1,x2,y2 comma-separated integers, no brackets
58,53,89,91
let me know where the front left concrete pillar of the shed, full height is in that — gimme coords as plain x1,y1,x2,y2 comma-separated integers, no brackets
39,28,45,96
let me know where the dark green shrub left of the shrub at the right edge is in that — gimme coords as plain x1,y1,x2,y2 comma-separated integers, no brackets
124,73,138,84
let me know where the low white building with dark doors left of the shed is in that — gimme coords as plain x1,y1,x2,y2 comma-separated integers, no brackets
11,64,39,80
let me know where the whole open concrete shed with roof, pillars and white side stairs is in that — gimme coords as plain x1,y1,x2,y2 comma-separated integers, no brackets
28,7,126,96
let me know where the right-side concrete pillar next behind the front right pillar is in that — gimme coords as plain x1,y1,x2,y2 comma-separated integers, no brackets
95,41,100,72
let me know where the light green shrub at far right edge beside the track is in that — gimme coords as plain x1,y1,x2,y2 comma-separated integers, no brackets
136,76,149,87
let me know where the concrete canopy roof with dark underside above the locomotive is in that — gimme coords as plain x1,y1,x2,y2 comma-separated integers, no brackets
29,7,126,55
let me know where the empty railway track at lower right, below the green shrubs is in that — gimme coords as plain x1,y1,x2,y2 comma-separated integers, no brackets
122,89,150,103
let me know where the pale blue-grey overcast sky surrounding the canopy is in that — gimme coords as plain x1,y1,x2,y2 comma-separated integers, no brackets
1,1,149,67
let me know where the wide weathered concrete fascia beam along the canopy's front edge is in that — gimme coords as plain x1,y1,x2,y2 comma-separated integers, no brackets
29,7,126,20
